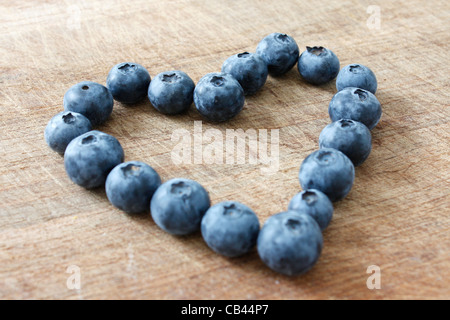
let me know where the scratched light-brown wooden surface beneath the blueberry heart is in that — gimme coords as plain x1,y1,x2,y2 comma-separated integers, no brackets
0,0,450,299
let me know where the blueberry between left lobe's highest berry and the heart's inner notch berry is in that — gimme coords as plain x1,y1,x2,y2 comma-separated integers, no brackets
148,71,195,114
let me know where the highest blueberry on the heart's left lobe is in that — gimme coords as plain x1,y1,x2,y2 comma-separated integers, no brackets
106,62,151,104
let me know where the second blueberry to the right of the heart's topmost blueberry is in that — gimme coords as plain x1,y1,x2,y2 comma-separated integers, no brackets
336,63,377,94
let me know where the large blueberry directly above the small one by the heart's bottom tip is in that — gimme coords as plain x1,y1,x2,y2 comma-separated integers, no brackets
298,148,355,202
